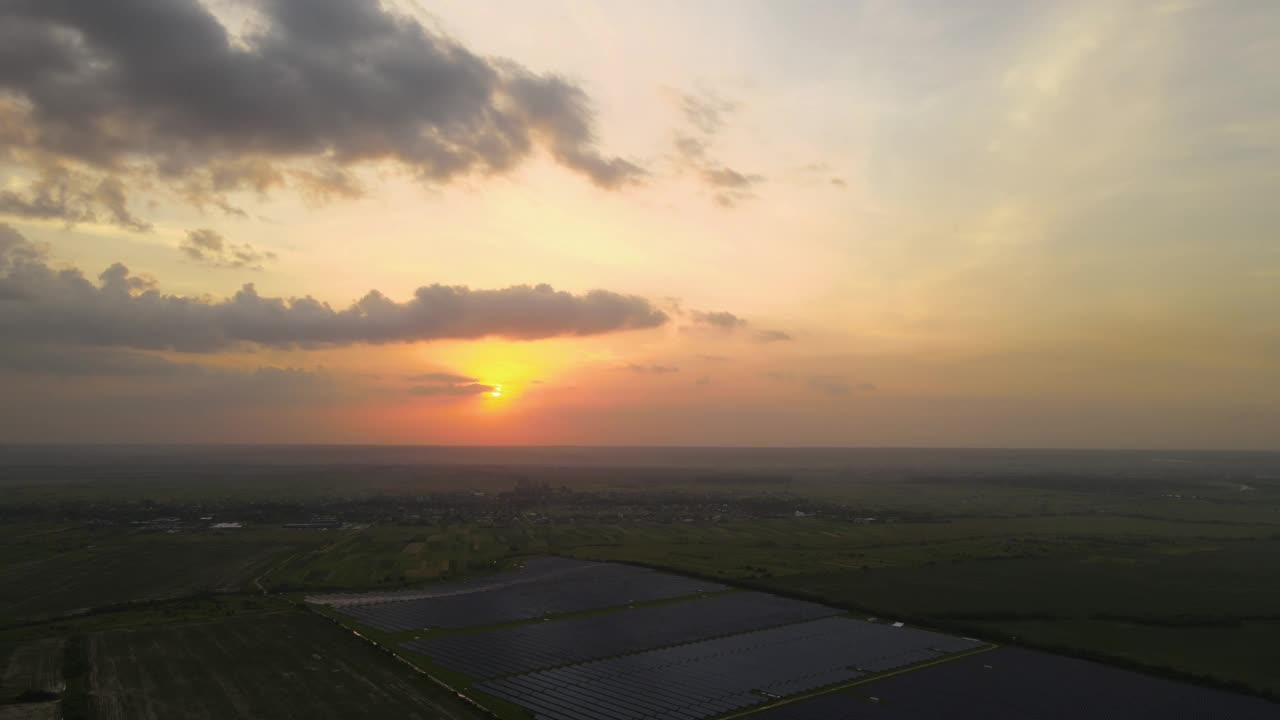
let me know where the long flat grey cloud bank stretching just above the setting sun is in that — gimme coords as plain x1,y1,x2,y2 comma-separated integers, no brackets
0,221,668,352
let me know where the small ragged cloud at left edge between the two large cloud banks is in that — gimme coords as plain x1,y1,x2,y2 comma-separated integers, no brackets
0,168,151,232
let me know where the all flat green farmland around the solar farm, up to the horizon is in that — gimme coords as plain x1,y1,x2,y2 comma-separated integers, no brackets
0,453,1280,717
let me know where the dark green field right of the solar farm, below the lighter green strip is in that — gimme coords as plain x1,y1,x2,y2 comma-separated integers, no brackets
762,541,1280,624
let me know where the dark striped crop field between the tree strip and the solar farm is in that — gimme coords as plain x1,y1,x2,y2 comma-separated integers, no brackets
80,611,472,720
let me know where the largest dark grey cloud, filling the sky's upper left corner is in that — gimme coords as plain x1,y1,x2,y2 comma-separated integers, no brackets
0,0,645,213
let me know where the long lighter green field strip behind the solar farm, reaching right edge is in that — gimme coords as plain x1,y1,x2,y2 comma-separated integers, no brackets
560,516,1280,577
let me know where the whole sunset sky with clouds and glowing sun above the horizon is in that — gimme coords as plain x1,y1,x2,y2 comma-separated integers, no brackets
0,0,1280,450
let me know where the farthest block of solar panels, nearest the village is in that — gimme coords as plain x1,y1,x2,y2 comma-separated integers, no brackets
338,562,724,632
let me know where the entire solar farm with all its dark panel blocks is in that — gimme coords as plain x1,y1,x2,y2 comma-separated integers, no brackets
308,557,1274,720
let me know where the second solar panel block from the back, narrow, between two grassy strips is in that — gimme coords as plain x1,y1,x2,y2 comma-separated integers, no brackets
404,592,841,679
